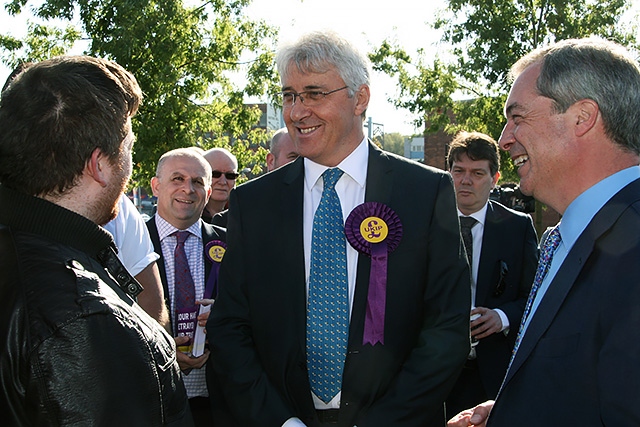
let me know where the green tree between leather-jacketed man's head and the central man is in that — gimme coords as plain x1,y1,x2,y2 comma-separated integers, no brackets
0,0,277,187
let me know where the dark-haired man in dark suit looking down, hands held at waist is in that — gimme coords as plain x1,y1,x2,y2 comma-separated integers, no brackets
446,132,538,416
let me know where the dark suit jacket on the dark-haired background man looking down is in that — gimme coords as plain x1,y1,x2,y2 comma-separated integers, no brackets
476,201,538,403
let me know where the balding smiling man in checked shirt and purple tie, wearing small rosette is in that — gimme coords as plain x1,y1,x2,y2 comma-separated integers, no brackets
147,148,225,426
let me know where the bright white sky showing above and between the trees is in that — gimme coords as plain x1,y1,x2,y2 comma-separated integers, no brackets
0,0,640,136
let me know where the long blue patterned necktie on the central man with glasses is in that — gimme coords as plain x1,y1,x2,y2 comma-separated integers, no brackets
307,168,349,403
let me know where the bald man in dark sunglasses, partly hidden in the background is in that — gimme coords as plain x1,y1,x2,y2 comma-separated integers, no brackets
202,147,240,227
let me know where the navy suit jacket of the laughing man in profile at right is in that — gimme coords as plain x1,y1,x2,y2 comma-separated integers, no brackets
489,180,640,427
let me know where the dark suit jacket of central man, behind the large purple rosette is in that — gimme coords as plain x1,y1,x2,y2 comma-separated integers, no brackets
207,144,470,427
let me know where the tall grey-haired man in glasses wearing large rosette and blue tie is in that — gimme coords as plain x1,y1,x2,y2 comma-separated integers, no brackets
207,33,470,427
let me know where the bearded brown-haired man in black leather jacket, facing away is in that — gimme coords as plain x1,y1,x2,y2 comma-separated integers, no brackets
0,57,192,426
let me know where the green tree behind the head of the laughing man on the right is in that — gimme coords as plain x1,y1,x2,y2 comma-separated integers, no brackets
369,0,635,182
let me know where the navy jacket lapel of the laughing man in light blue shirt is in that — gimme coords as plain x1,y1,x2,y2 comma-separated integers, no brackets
503,180,640,387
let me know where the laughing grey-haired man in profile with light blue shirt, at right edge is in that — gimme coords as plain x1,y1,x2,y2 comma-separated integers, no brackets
449,38,640,427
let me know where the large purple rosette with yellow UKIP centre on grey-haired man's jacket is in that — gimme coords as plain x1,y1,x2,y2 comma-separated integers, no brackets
344,202,402,345
